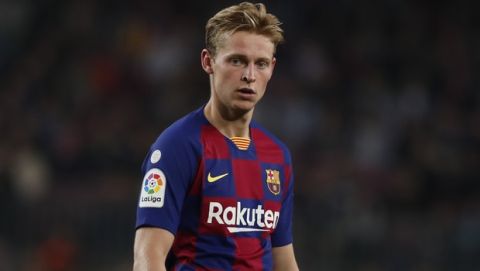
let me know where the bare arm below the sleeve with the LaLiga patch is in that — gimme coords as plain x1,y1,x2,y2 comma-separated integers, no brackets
133,227,174,271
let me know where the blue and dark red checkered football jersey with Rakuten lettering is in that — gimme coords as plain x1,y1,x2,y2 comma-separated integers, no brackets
136,108,293,270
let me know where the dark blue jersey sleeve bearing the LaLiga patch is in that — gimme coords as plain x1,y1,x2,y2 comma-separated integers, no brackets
136,131,198,235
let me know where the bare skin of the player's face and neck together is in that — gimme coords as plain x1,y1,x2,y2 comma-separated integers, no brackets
201,31,276,137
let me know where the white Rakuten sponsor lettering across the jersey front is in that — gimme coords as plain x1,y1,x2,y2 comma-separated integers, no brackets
207,201,280,232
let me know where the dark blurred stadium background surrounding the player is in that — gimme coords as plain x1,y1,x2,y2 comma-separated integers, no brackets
0,0,480,271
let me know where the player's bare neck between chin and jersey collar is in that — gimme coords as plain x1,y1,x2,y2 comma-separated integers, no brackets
203,100,253,138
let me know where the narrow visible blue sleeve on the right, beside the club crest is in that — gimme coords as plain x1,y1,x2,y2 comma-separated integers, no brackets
271,151,294,247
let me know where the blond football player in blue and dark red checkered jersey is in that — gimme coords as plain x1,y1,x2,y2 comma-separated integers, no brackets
134,2,298,271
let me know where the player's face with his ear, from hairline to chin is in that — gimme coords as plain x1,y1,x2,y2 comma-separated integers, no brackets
202,31,276,114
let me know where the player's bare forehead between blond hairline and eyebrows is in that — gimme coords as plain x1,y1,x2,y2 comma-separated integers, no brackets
217,31,275,58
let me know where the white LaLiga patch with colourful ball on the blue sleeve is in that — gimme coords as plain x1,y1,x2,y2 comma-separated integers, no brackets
138,168,167,208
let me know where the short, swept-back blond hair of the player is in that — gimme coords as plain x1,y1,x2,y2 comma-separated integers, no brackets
205,2,284,56
